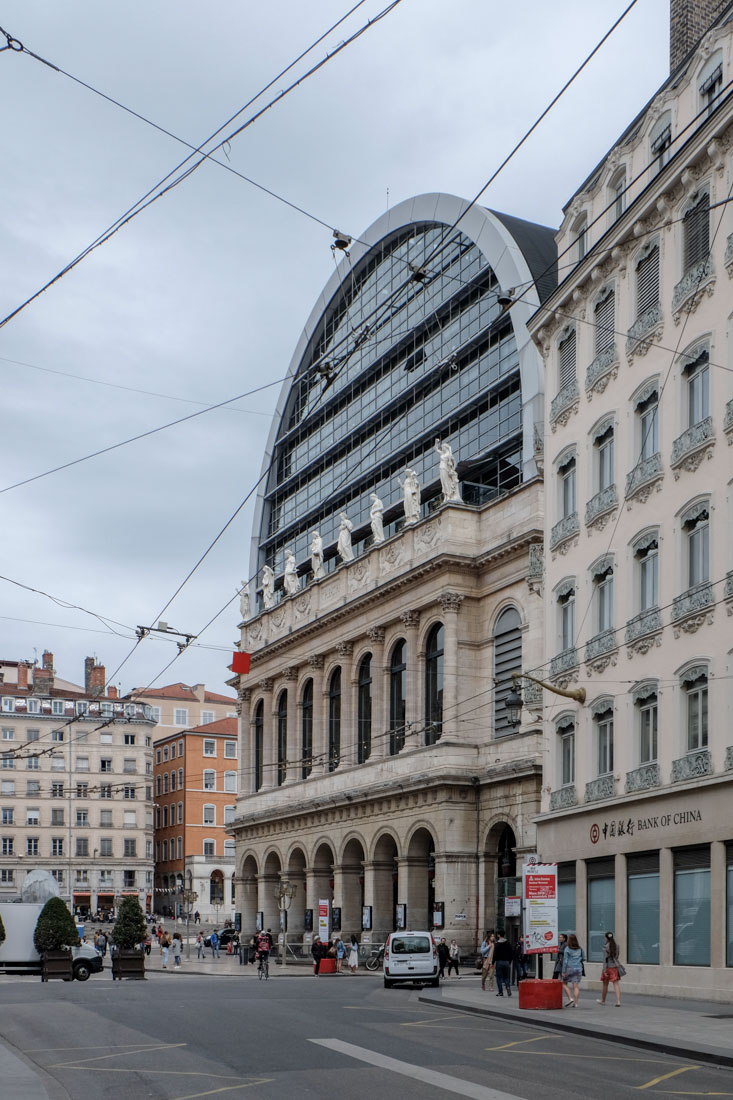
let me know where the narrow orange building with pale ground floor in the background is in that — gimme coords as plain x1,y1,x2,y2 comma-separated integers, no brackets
153,718,239,924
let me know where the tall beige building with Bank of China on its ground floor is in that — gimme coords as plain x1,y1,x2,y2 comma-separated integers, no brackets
530,2,733,1000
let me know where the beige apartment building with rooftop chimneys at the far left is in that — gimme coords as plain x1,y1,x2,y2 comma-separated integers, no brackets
0,652,155,915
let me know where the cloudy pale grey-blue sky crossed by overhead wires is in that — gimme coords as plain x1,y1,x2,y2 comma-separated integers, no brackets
0,0,668,691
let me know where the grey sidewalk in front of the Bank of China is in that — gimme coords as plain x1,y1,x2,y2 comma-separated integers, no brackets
418,979,733,1066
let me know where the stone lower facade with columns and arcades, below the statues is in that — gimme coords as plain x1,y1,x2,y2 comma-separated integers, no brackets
232,495,541,948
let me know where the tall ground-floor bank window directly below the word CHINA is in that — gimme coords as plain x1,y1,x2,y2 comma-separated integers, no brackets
674,846,710,966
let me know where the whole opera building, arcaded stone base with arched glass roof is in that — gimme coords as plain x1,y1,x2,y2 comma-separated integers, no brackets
230,195,555,947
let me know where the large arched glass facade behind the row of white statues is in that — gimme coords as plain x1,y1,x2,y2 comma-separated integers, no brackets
258,206,545,602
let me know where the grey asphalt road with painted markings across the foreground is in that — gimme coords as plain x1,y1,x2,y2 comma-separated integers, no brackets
0,969,733,1100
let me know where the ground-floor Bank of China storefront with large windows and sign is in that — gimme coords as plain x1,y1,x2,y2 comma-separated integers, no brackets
530,778,733,1000
